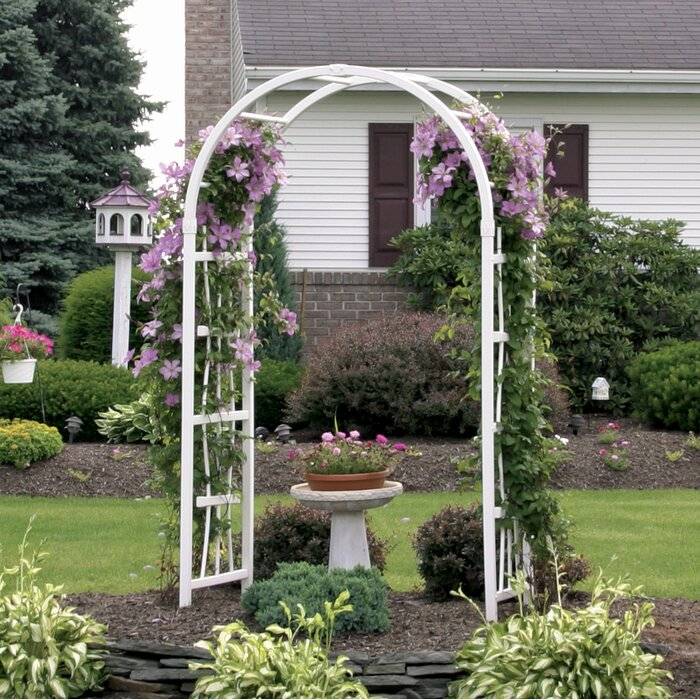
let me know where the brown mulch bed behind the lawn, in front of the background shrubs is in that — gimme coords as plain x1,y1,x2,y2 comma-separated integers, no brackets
0,418,700,498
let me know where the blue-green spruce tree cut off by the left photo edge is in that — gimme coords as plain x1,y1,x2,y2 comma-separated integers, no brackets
0,0,74,312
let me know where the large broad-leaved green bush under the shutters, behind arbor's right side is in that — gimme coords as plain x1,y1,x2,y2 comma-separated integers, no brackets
392,199,700,410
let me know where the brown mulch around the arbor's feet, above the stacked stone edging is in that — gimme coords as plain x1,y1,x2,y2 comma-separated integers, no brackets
69,588,700,698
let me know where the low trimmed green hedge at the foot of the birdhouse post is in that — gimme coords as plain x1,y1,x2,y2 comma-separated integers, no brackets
0,360,140,440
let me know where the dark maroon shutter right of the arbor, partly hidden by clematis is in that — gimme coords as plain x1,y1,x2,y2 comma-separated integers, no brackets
545,124,588,201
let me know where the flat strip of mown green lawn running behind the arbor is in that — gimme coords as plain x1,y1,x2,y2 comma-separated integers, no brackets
0,490,700,599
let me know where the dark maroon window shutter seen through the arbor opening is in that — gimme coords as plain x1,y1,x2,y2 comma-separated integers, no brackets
369,124,415,267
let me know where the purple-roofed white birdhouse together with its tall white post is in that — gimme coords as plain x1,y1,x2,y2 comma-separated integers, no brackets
90,170,153,366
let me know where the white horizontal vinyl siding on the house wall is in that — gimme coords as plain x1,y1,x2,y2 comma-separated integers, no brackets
267,91,700,270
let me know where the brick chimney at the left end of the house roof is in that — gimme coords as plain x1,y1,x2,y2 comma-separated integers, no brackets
185,0,232,141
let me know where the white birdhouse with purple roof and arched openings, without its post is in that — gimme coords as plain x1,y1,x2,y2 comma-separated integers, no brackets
90,170,153,250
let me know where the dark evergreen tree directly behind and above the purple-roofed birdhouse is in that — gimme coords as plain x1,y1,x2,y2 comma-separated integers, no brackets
34,0,162,206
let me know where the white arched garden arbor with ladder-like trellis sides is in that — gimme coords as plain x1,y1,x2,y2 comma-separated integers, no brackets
180,64,515,619
